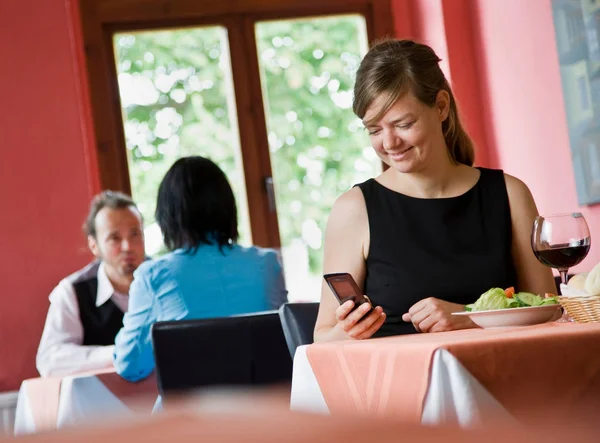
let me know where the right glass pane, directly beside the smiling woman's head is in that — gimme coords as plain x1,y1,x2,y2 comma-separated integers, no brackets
256,15,381,301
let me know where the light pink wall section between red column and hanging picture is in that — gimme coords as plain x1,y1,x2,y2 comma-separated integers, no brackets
472,0,600,271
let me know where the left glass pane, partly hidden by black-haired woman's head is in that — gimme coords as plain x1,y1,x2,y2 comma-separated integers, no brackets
113,26,252,254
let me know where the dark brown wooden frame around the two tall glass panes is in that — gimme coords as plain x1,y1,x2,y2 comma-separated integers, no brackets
79,0,394,248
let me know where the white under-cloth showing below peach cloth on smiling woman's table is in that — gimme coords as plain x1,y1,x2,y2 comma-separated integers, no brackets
291,346,516,427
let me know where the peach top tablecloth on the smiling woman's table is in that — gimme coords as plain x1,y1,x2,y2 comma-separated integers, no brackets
306,323,600,423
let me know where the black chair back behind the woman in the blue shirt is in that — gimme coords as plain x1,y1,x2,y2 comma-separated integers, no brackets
152,311,292,397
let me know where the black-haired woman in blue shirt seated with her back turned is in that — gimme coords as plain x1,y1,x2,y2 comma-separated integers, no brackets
114,157,287,381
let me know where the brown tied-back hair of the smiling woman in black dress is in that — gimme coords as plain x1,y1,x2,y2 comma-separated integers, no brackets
353,39,475,166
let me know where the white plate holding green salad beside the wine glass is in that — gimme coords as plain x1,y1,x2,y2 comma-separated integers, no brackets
452,305,560,328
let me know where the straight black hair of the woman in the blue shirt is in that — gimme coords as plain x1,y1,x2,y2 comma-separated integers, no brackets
156,156,238,251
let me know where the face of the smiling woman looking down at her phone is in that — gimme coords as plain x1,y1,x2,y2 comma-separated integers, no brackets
363,91,450,172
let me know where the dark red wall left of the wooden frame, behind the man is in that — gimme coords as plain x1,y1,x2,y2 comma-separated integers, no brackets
0,0,94,392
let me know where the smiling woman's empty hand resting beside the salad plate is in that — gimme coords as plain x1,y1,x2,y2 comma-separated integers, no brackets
402,297,477,332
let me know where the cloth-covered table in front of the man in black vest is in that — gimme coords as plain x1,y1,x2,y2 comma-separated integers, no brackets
14,370,158,435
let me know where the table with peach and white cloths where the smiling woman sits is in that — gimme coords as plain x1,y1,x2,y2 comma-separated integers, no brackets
291,323,600,427
